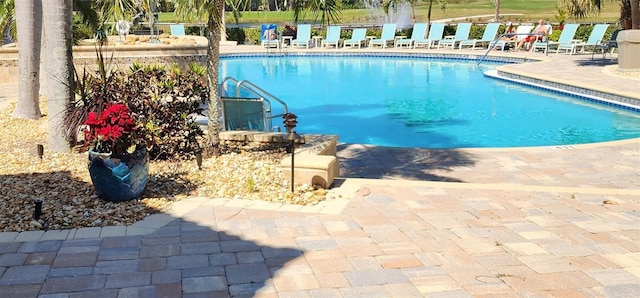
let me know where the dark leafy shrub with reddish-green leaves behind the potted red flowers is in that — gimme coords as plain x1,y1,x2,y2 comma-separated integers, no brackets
65,52,208,159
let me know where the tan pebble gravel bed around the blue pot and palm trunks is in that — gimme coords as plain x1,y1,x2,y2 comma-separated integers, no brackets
0,100,330,232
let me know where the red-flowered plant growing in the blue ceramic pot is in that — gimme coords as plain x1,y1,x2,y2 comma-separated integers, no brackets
84,103,141,155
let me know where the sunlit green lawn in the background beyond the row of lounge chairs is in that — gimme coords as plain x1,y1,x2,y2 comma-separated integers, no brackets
160,0,620,26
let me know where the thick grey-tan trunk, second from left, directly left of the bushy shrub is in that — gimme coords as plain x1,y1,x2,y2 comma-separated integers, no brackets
42,0,74,152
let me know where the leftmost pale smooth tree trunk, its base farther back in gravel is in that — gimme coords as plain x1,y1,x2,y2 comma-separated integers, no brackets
13,0,42,119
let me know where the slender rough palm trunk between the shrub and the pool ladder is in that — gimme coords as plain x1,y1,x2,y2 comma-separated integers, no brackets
207,0,224,156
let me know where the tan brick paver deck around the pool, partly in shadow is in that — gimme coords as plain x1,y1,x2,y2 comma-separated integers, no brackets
0,43,640,297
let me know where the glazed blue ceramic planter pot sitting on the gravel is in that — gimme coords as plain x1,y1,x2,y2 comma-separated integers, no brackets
89,148,149,202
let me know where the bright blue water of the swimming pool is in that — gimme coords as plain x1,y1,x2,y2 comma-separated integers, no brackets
220,56,640,148
